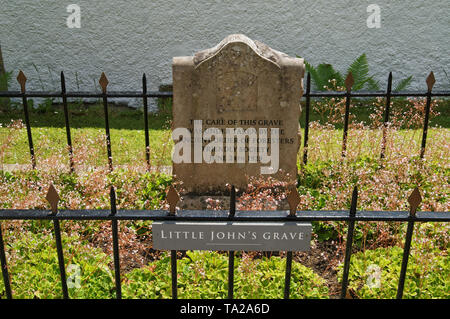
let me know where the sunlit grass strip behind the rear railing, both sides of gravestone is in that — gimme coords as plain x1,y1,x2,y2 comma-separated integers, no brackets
0,127,450,166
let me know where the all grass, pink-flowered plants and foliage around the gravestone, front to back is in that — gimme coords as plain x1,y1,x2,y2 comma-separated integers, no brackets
0,88,450,298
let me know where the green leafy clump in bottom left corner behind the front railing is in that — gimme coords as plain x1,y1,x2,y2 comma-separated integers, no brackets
0,231,114,299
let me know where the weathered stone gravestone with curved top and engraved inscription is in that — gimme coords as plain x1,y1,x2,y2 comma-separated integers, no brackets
172,34,305,205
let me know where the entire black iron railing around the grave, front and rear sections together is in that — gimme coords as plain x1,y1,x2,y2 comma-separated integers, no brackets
0,72,450,299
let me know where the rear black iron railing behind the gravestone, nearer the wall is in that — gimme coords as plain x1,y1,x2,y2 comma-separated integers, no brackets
0,71,450,171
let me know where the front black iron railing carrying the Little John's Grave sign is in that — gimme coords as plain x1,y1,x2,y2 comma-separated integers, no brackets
0,186,450,299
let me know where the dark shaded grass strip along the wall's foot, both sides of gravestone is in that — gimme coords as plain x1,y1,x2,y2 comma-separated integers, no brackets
0,98,450,130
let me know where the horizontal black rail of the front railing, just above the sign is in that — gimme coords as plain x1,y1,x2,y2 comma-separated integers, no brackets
0,209,450,222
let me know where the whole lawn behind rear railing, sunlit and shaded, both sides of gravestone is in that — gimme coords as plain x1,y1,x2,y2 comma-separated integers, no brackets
0,100,450,166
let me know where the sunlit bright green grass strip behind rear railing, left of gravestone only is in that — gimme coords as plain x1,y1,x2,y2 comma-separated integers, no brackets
0,127,172,166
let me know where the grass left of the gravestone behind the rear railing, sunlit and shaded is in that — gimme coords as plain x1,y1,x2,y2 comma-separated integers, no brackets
0,105,173,166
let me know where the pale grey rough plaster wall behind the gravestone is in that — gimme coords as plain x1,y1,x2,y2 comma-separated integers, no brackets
0,0,450,109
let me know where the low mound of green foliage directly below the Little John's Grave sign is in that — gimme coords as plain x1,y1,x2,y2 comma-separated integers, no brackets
123,251,328,299
